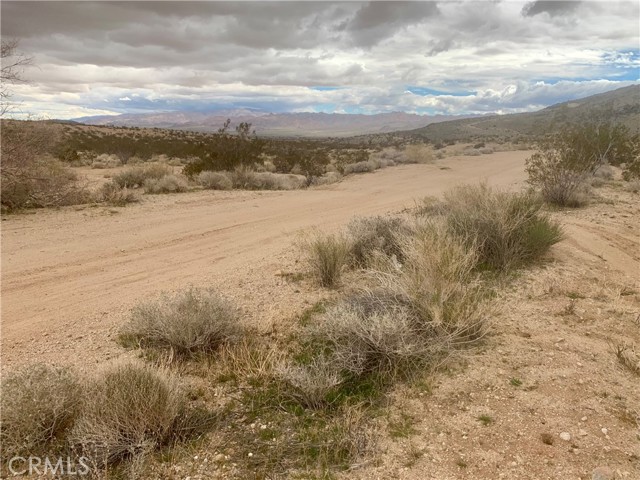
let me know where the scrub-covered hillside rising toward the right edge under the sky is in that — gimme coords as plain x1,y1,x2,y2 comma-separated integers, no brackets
405,85,640,141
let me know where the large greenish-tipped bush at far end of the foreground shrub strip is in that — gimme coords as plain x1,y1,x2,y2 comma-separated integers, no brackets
432,184,562,270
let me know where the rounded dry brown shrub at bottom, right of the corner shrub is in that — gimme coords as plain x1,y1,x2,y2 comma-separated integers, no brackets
71,363,192,470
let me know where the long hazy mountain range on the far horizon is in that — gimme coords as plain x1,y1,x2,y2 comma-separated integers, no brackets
75,110,476,137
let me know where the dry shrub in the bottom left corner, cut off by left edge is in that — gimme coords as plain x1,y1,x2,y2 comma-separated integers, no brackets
0,364,80,459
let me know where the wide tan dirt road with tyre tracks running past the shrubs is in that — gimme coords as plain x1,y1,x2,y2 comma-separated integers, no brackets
2,151,531,364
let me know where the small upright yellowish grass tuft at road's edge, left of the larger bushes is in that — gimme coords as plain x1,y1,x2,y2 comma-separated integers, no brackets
303,233,349,288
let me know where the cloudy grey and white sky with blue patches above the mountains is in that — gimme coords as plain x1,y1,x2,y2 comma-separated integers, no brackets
0,0,640,118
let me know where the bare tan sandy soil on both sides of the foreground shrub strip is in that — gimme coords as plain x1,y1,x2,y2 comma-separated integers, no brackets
2,151,640,480
